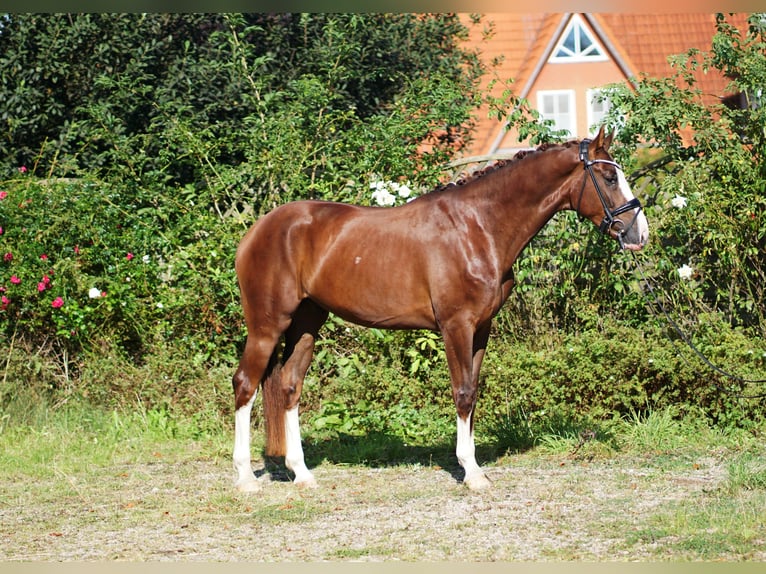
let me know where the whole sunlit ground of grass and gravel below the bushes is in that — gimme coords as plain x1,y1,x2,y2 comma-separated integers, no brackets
0,405,766,561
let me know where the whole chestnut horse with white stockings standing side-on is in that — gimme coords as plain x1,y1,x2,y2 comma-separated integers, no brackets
233,128,649,491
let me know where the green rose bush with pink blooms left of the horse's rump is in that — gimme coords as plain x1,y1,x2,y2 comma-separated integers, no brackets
0,178,242,368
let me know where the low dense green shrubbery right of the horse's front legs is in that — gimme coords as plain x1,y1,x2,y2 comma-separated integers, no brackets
480,315,766,432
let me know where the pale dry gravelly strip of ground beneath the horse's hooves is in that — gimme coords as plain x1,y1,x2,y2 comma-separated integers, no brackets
0,450,766,562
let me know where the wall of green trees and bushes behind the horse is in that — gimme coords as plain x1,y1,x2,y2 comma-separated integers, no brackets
0,14,766,442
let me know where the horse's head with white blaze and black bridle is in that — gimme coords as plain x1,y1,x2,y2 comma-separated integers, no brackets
572,127,649,251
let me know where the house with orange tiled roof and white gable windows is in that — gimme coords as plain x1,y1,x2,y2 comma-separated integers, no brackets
463,13,747,156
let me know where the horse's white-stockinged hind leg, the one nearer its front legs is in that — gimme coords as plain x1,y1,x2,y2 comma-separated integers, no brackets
280,300,327,487
